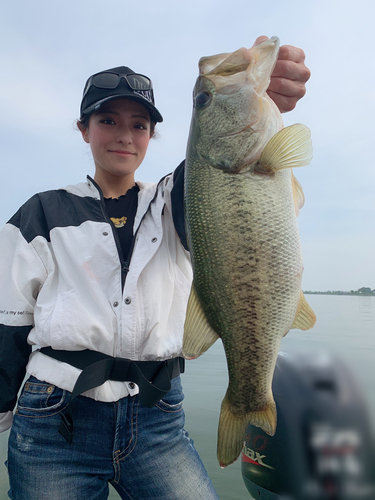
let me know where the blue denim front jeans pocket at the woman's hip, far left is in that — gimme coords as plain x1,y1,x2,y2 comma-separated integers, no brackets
16,377,70,417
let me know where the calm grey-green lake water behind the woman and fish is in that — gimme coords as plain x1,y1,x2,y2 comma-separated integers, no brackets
0,295,375,500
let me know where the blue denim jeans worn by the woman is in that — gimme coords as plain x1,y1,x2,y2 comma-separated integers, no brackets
8,377,218,500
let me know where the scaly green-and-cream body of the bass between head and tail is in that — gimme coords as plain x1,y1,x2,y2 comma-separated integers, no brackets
186,164,302,400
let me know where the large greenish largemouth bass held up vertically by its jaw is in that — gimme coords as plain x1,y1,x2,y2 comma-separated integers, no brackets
183,37,316,467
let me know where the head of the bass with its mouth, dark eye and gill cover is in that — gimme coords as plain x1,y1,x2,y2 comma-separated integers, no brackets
190,37,282,173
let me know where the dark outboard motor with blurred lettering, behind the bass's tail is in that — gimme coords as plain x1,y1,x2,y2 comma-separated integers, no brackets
242,352,375,500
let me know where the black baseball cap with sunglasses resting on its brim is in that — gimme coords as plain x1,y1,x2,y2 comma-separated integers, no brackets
81,66,163,122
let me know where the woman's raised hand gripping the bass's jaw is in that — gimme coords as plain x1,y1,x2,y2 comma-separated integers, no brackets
254,36,311,113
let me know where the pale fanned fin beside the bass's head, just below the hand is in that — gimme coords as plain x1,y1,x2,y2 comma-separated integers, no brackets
259,123,312,172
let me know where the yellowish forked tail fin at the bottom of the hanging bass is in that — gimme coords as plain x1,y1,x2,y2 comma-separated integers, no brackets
217,394,276,468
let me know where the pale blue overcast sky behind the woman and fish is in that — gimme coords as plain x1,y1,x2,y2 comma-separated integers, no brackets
0,0,375,290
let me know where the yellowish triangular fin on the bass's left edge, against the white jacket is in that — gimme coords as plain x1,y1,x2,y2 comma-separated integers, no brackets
182,282,219,359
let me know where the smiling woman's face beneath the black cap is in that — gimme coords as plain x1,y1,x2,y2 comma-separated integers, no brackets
81,99,151,181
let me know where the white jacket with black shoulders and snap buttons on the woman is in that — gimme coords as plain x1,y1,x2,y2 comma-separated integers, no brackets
0,163,192,431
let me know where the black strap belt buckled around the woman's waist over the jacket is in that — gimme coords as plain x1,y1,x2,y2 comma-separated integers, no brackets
40,347,185,444
